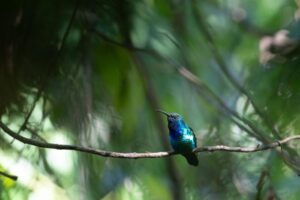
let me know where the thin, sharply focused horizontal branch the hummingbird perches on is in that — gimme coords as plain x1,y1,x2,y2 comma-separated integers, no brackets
0,121,300,159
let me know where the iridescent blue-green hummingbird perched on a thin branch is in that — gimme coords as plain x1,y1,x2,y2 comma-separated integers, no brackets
157,110,198,166
